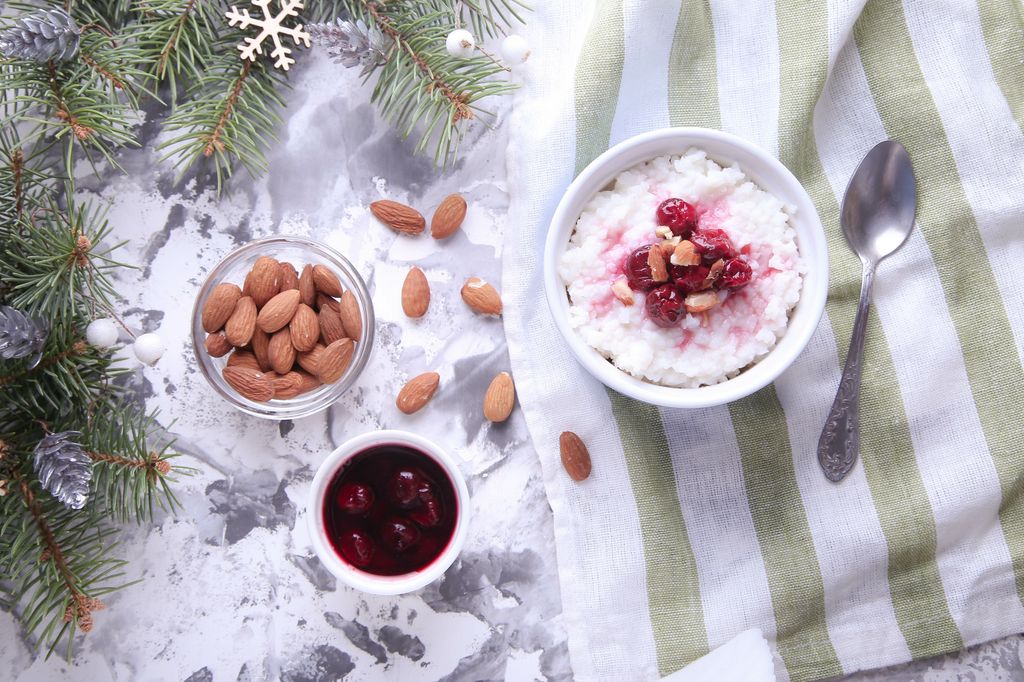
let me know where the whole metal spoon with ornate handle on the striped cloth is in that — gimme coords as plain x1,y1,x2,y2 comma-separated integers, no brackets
818,140,918,481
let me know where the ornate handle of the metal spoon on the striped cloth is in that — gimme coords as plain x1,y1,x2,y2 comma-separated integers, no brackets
818,263,874,482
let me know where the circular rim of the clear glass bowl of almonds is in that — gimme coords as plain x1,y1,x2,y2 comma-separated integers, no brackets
191,235,377,421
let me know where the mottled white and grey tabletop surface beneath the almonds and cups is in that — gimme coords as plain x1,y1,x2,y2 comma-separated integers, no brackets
0,49,1024,682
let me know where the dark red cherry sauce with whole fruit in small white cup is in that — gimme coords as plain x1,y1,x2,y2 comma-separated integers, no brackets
324,444,459,576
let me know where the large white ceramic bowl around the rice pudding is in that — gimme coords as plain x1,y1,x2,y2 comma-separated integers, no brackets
544,128,828,408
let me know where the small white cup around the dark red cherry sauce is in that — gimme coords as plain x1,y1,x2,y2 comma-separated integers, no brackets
306,431,469,595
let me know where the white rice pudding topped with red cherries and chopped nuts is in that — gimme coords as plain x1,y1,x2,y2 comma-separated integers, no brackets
558,148,806,388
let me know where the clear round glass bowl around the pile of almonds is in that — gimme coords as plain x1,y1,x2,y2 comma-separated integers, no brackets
191,237,375,420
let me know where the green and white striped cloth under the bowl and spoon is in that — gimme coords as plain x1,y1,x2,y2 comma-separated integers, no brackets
503,0,1024,681
